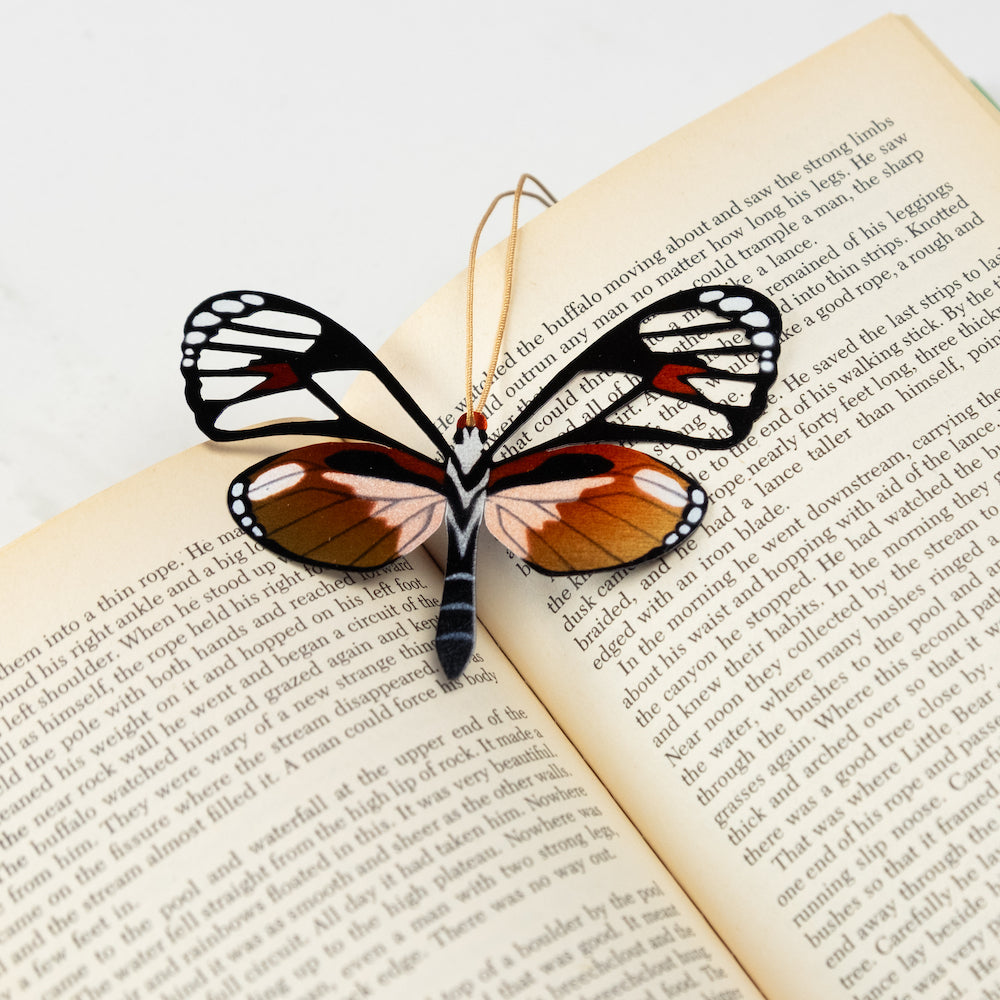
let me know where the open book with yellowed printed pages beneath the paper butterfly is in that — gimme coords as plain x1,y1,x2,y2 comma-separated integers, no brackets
0,17,1000,1000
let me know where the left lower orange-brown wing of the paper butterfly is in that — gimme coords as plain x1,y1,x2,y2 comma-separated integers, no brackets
229,443,445,569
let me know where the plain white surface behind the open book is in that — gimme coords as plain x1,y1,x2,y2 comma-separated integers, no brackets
0,0,1000,544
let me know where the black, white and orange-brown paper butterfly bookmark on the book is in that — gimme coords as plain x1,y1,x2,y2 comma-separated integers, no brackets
181,287,781,677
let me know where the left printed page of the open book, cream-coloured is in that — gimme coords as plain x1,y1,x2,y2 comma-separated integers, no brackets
0,439,759,1000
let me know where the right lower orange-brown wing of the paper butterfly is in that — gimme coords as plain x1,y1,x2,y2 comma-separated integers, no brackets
484,444,707,575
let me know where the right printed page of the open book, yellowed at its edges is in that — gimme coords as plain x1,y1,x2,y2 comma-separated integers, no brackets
360,18,1000,998
